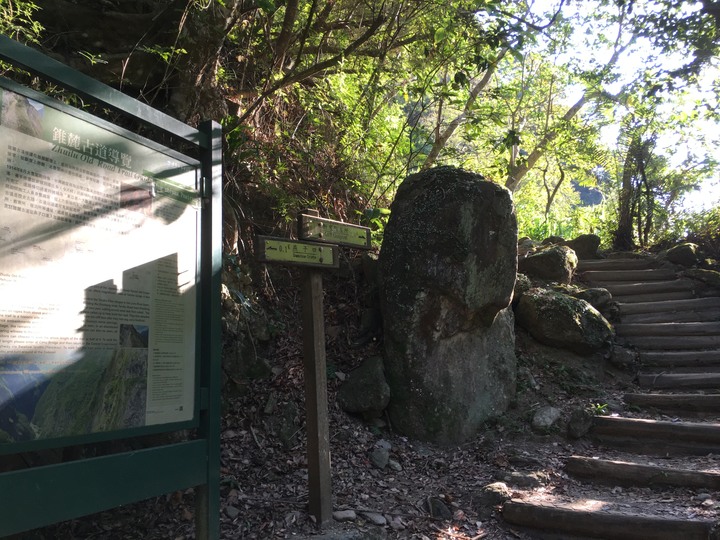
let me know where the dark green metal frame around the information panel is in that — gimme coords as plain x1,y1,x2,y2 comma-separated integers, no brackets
0,36,222,540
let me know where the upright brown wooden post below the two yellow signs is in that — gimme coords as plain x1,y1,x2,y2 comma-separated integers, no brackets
302,269,332,526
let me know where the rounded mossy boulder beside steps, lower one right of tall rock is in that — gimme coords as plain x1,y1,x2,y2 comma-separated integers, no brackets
515,288,613,355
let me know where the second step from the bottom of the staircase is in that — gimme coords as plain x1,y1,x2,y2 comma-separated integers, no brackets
565,456,720,490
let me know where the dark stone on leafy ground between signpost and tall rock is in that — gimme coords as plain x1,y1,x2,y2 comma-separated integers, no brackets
337,356,390,419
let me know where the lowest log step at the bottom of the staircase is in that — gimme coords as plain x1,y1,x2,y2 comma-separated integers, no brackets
502,500,714,540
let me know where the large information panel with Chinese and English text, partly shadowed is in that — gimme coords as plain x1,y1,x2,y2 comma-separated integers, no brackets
0,83,199,452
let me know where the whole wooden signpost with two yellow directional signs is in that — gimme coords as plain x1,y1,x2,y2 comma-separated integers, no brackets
257,210,370,526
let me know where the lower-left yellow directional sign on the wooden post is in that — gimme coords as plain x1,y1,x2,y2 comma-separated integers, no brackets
257,236,340,268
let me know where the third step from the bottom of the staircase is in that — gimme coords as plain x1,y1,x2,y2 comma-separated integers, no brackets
590,416,720,455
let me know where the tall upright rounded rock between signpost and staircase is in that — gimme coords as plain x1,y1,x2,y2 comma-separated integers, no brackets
379,167,517,444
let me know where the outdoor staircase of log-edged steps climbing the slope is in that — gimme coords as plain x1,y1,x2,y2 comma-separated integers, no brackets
502,257,720,540
